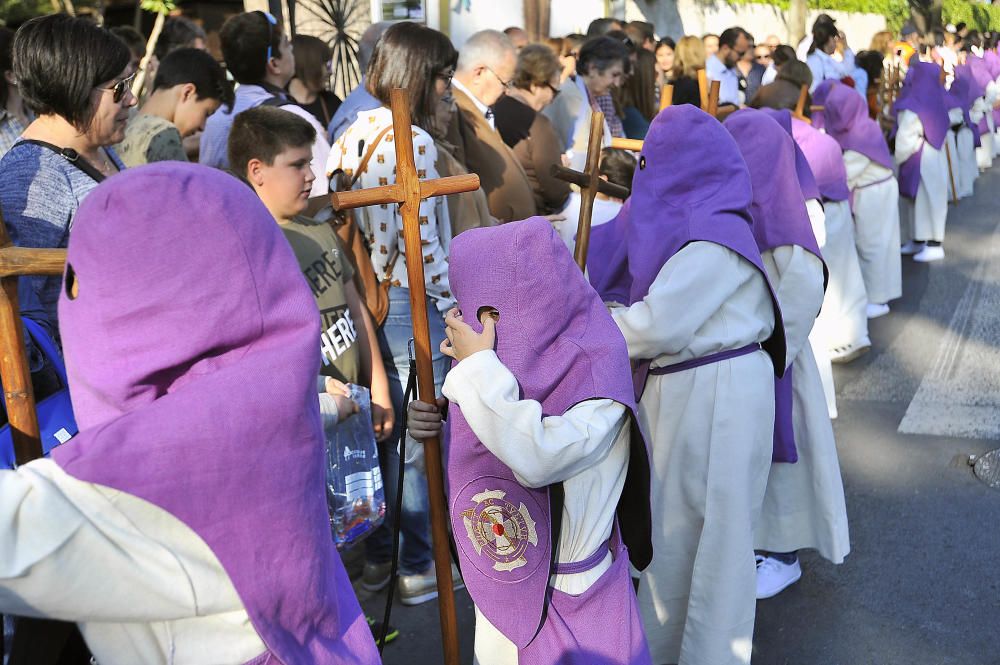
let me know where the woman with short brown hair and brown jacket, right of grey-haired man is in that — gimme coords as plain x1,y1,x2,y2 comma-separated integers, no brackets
493,44,569,215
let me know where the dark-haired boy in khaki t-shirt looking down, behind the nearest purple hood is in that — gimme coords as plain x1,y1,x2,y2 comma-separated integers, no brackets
116,48,233,166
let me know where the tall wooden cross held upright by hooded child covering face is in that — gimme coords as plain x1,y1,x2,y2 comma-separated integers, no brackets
330,88,479,665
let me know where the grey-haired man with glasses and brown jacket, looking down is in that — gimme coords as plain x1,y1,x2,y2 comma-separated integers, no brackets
451,30,536,222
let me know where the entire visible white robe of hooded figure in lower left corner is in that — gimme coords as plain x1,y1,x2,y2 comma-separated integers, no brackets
0,459,265,665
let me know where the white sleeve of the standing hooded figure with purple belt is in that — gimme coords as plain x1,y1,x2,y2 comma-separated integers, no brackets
611,241,752,360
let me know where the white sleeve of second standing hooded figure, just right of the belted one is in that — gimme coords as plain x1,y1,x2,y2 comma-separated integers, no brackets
764,245,823,367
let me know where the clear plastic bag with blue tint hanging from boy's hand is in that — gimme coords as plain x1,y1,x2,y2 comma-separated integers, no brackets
326,385,385,549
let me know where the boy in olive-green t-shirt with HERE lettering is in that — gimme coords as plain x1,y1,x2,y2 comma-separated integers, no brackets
229,106,393,442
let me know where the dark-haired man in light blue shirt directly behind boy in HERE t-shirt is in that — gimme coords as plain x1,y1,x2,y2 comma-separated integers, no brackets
199,11,330,197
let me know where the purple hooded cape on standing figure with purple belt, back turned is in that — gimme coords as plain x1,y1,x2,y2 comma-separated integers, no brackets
625,104,785,376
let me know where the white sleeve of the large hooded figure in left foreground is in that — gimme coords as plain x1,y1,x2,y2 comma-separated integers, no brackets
0,459,248,620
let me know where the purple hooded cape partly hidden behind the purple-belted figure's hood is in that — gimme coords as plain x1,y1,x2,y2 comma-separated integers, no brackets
724,109,829,462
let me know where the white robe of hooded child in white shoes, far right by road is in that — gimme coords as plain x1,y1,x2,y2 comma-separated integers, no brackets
895,110,948,242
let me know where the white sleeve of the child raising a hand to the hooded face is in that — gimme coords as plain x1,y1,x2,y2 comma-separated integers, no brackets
442,351,626,487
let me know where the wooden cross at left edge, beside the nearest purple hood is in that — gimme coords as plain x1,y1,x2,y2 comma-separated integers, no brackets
0,215,66,465
